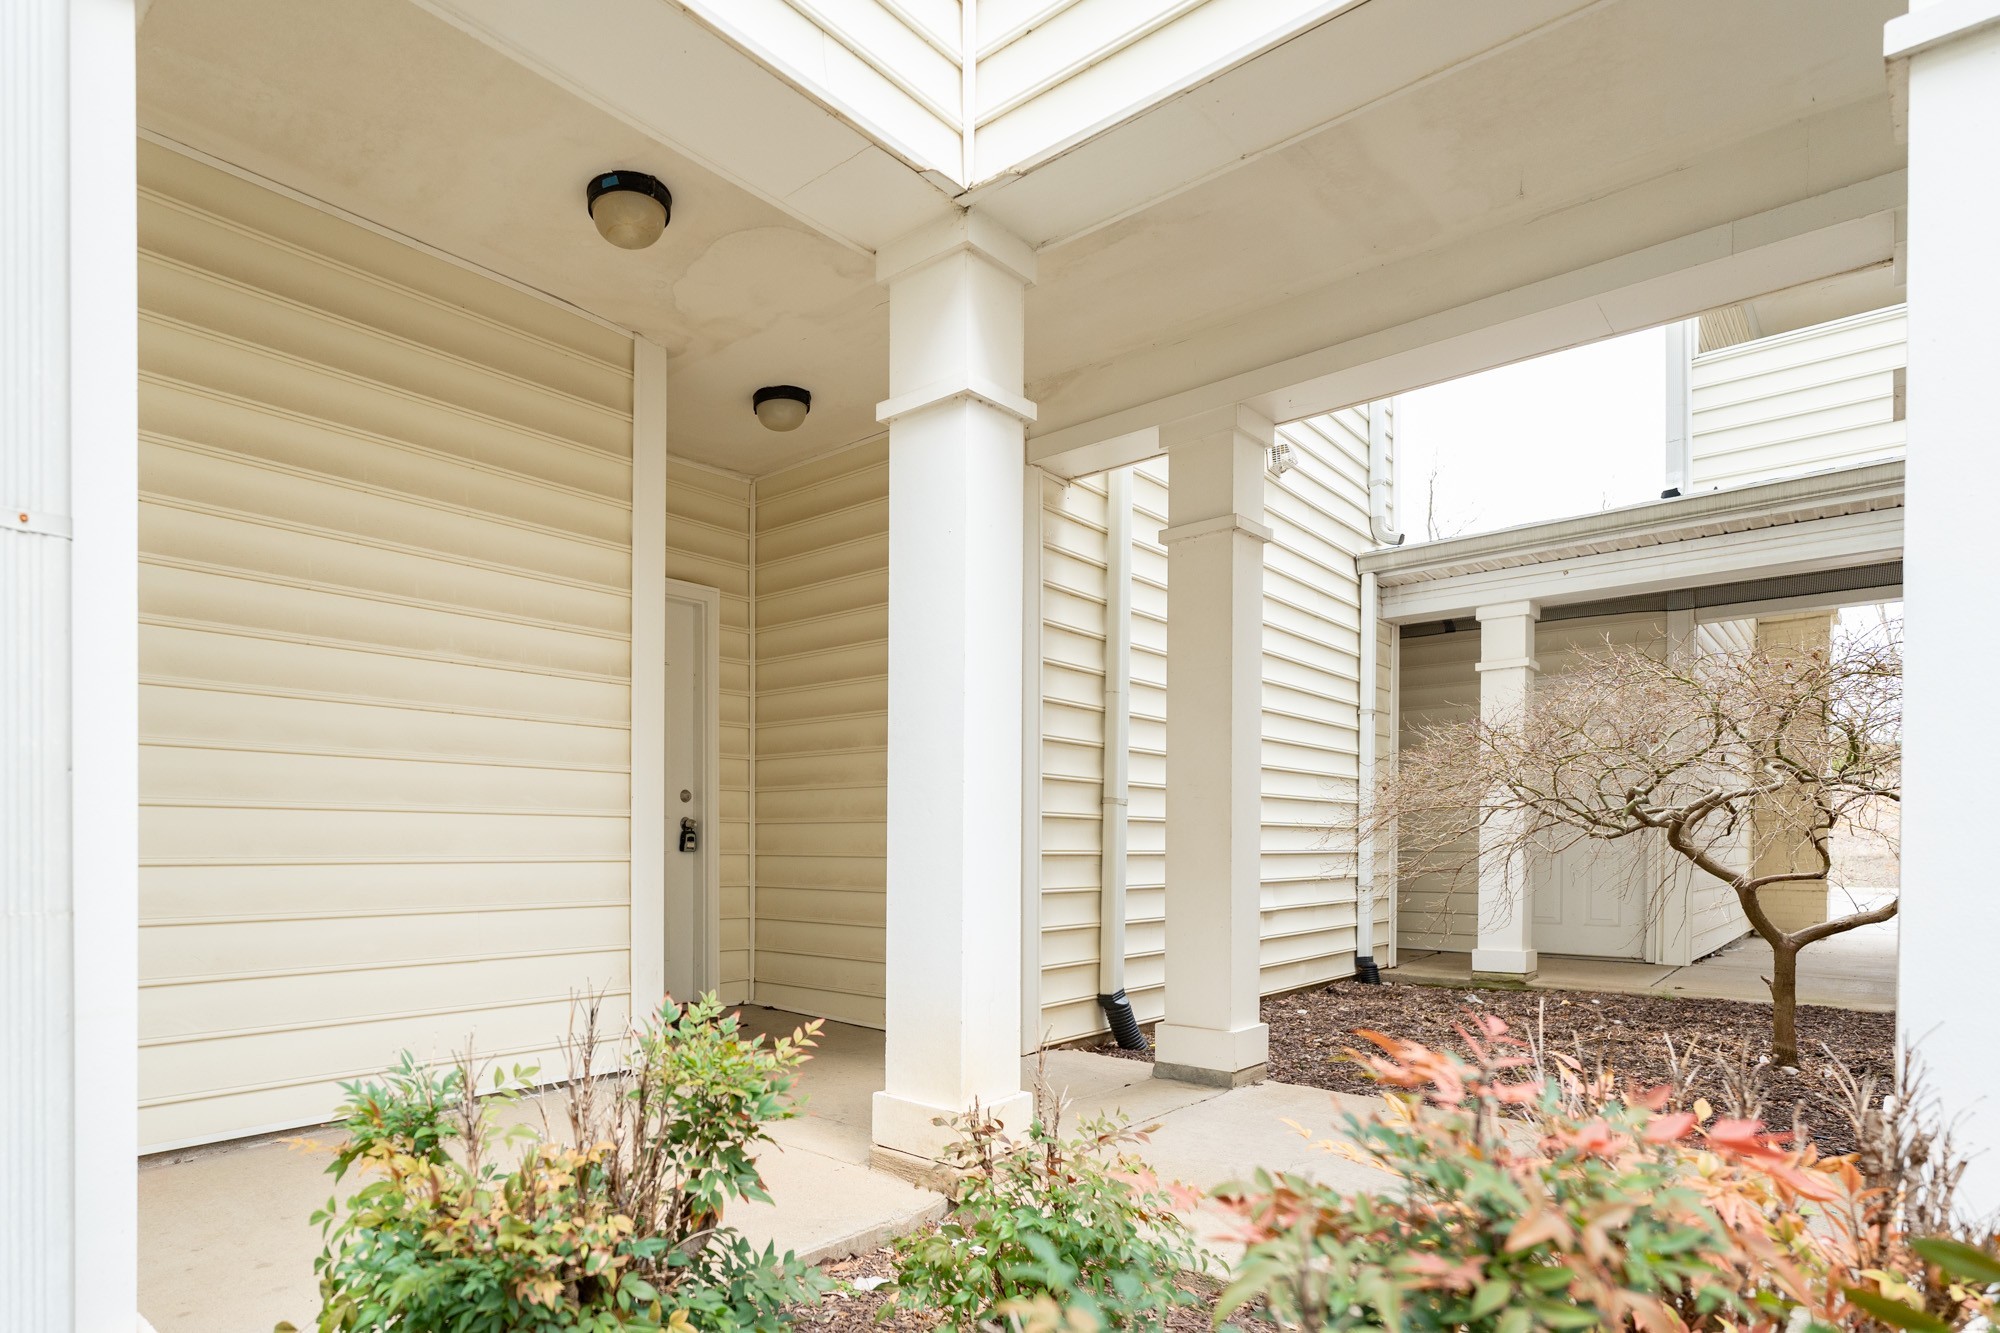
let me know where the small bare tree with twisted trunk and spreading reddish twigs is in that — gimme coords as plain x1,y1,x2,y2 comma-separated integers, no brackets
1360,622,1902,1065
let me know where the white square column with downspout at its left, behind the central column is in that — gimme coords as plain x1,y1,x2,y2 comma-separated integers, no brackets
1154,408,1272,1085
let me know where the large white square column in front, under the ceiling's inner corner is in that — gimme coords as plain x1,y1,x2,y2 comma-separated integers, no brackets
874,214,1034,1165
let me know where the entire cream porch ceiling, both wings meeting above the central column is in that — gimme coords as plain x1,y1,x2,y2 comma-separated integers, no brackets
140,0,1902,474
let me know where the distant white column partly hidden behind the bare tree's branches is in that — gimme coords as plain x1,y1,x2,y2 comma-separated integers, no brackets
1472,602,1542,981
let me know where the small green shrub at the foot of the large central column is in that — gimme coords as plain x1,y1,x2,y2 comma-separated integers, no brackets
892,1107,1204,1329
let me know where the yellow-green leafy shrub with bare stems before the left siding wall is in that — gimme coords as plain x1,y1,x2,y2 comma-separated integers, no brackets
280,997,818,1333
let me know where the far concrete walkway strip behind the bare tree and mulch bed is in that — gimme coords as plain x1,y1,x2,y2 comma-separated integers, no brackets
1382,897,1896,1013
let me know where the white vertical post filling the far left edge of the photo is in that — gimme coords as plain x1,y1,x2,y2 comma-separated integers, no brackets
0,0,138,1331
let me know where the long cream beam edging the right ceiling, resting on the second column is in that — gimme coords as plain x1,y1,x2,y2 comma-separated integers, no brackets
1028,170,1906,472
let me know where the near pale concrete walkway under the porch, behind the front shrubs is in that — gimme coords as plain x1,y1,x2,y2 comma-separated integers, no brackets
140,1009,1380,1333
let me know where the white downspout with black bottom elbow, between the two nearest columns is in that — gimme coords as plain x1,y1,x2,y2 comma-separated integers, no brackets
1098,468,1132,995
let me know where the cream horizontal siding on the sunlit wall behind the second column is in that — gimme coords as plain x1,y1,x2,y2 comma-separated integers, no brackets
1042,410,1390,1041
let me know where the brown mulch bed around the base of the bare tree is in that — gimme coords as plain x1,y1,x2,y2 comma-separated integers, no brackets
1098,981,1896,1155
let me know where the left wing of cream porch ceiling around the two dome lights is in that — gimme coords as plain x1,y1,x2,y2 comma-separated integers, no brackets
138,0,888,474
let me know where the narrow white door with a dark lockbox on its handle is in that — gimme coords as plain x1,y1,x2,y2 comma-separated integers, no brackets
662,584,720,999
